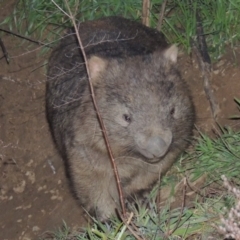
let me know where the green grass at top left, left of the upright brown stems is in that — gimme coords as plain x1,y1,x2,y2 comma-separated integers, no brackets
1,0,161,40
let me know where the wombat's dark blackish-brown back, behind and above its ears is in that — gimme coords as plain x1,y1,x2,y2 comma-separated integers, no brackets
51,17,168,58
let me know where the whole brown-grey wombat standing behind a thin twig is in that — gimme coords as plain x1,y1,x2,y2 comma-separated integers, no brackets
46,17,194,221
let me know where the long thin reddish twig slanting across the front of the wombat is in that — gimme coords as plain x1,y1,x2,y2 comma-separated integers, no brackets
64,0,126,217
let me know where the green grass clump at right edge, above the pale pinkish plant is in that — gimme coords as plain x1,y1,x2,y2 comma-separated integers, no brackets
181,128,240,184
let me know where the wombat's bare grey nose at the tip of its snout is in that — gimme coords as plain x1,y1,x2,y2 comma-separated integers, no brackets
146,136,172,157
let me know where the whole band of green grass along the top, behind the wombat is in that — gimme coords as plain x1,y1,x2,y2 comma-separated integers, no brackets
2,0,240,59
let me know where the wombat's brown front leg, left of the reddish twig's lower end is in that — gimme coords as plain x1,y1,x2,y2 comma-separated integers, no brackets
67,152,119,221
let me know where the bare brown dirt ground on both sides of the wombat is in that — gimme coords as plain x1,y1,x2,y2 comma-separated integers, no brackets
0,1,240,240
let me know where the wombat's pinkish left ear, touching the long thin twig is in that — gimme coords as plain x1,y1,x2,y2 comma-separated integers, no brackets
88,56,107,84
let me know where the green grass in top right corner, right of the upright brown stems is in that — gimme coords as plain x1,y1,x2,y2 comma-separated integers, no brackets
155,0,240,59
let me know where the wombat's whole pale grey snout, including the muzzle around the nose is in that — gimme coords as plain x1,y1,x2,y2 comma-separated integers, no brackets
136,130,172,159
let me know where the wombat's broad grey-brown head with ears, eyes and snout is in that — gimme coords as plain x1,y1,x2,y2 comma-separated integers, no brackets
85,46,194,162
